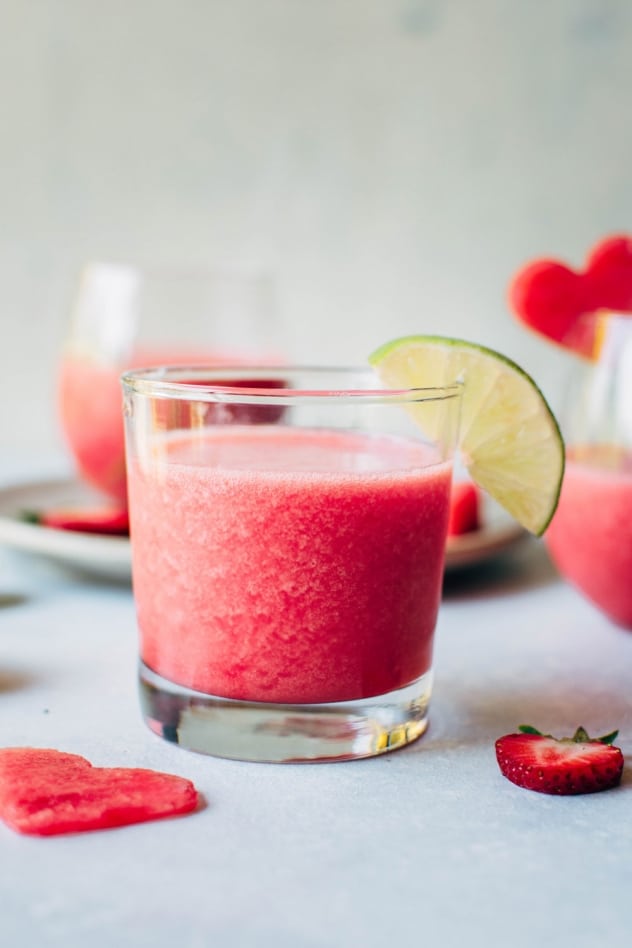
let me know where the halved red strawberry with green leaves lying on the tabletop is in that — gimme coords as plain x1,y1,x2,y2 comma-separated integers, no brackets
496,725,623,796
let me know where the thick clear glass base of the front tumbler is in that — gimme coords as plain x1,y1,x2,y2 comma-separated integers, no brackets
139,662,432,763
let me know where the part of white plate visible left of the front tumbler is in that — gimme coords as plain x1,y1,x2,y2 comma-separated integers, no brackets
0,479,131,580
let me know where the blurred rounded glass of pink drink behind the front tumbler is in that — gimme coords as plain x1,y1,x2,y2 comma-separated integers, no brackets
58,262,282,504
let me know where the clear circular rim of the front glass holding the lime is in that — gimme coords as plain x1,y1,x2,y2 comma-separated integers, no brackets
120,363,463,404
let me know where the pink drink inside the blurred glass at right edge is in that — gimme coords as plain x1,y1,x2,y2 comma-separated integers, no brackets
546,448,632,629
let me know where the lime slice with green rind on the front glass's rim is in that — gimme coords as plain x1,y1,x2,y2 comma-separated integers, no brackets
369,336,564,536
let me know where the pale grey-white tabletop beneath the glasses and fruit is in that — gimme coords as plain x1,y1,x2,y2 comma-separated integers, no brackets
0,456,632,948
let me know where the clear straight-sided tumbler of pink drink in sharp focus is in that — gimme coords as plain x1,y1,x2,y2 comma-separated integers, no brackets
123,366,461,761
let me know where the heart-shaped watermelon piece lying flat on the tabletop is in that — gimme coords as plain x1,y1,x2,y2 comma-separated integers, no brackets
0,747,198,836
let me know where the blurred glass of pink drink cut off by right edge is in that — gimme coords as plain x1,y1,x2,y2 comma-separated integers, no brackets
546,314,632,629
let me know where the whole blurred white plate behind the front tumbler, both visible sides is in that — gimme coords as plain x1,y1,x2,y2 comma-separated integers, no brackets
0,479,526,580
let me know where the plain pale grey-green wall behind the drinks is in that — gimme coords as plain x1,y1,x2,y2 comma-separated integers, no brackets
0,0,632,453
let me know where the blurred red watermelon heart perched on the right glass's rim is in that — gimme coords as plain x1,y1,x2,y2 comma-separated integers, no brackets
509,235,632,359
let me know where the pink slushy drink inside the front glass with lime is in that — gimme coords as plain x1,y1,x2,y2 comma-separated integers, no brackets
129,425,451,703
